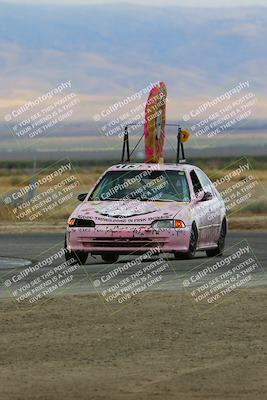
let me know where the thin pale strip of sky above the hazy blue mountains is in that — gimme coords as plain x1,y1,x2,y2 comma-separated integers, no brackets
0,0,267,7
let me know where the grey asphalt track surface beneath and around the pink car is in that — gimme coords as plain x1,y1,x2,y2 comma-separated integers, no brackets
0,231,267,298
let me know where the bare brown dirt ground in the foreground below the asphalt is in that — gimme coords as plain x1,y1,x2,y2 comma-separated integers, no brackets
0,289,267,400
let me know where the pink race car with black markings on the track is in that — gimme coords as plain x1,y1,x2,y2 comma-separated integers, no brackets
66,163,227,264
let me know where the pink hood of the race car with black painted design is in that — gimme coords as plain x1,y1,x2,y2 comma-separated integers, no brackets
71,200,188,224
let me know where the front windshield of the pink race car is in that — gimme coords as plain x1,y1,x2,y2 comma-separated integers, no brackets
89,170,190,202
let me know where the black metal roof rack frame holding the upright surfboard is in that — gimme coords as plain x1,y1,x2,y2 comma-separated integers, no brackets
121,123,186,164
